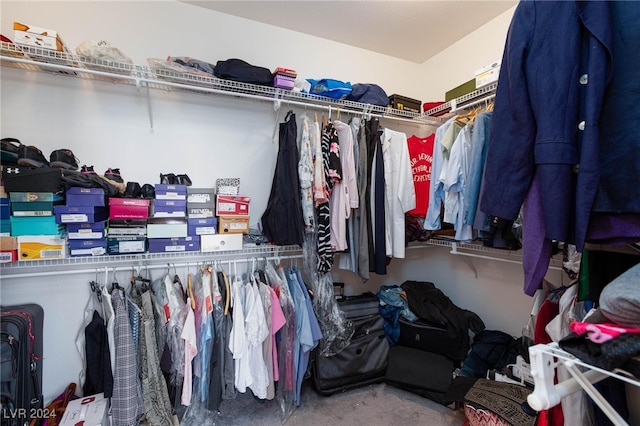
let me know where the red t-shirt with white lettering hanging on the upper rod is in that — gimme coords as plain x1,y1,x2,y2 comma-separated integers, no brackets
407,133,436,218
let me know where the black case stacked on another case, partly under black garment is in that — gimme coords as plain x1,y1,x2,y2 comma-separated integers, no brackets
398,317,470,361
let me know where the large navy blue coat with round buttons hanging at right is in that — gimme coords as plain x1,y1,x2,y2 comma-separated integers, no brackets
480,1,611,250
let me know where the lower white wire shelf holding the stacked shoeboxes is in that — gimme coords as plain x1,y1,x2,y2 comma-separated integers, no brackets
0,244,302,279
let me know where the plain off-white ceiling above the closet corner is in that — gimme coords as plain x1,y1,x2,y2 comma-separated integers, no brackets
184,0,517,64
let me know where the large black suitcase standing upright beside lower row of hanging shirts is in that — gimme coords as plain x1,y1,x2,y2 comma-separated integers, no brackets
312,293,389,396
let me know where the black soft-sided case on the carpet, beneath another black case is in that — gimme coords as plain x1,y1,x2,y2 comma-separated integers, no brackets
385,345,457,405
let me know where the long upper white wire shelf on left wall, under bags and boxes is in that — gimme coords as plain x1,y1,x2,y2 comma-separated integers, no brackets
0,42,443,125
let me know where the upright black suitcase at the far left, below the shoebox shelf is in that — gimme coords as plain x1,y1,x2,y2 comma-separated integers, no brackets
0,303,44,426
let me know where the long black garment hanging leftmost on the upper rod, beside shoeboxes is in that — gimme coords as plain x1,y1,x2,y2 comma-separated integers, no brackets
261,111,304,246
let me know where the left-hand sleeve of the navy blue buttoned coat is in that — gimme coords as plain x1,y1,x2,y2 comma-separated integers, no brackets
480,1,536,220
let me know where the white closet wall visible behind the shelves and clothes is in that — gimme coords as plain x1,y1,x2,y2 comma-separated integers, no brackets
0,1,560,406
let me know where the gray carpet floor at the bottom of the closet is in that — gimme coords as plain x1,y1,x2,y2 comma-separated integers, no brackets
215,381,465,426
